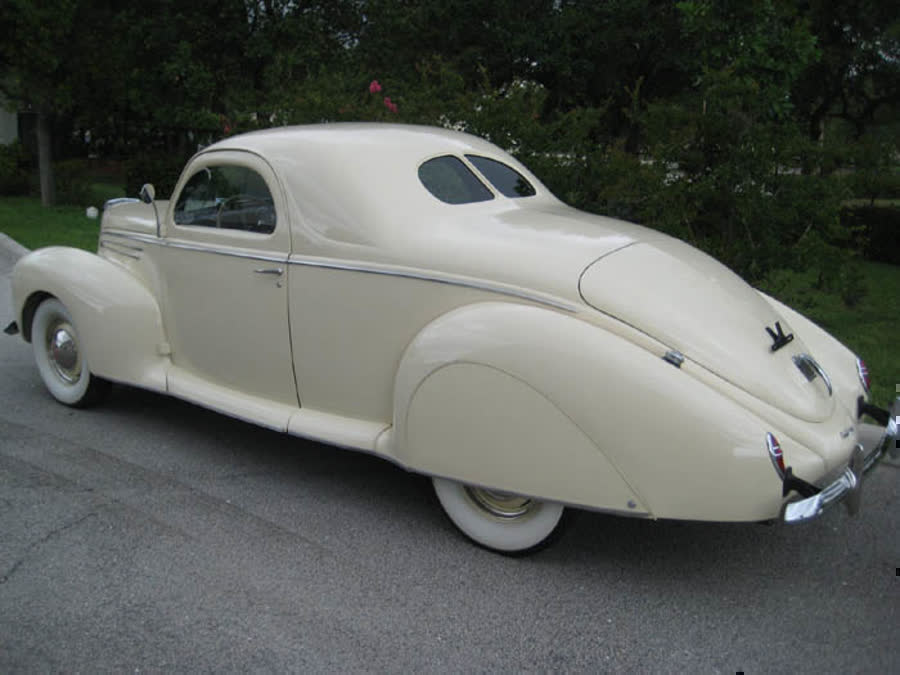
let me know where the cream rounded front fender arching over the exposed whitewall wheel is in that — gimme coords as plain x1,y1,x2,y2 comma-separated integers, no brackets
12,246,169,391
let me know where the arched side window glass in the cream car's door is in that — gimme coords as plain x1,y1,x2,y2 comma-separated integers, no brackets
175,166,275,234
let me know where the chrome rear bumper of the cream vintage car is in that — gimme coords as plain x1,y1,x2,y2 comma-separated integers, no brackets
782,398,900,523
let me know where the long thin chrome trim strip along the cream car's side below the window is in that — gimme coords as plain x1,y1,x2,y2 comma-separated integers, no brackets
104,231,578,313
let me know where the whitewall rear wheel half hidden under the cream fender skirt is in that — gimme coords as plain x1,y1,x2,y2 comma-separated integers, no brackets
432,478,564,554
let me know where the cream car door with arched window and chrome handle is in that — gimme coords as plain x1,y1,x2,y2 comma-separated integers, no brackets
155,151,298,407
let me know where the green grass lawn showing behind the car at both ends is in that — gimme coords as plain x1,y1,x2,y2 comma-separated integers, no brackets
0,195,900,405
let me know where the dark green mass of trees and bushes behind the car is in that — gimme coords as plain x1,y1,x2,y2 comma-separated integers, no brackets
0,0,900,303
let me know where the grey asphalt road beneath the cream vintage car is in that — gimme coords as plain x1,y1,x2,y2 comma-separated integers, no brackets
0,236,900,673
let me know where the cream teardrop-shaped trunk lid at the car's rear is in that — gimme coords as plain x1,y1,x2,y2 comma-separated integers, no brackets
579,235,834,422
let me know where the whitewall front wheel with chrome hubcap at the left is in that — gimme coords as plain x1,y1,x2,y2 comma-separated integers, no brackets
31,298,110,408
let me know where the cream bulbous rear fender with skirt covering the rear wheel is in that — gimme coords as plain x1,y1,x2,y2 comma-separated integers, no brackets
394,303,808,520
